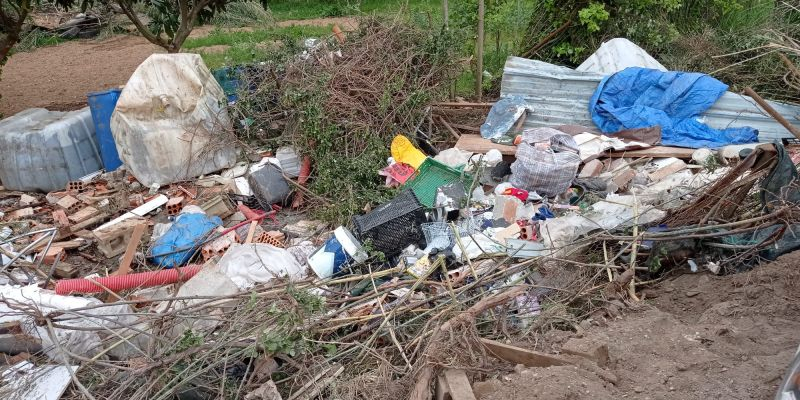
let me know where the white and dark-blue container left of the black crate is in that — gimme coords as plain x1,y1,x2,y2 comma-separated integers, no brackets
308,226,368,279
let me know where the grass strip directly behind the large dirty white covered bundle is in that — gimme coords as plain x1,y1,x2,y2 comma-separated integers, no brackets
183,26,331,70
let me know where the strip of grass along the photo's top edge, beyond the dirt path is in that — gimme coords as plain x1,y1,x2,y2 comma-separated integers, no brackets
269,0,441,21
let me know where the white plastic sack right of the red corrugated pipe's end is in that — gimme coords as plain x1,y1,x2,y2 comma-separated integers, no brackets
217,243,306,290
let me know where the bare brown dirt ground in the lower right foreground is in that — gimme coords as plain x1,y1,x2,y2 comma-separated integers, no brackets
473,252,800,400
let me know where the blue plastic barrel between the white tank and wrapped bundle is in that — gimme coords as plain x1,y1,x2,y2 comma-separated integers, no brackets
89,89,122,171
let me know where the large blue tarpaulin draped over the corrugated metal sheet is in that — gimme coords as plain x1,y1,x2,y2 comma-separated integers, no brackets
589,67,758,148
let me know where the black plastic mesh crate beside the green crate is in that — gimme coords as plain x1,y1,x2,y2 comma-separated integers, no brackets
353,190,426,257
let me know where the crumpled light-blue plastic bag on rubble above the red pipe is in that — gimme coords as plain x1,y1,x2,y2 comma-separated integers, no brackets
150,213,222,268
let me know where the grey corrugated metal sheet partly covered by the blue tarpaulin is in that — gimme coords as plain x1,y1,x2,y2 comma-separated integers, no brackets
500,57,800,142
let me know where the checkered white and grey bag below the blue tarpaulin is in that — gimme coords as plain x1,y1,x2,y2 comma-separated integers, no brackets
510,128,581,197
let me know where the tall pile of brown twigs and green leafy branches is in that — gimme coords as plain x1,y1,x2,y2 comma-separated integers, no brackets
225,18,457,223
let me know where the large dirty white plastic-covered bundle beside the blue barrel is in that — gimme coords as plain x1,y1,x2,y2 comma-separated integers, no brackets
111,54,236,186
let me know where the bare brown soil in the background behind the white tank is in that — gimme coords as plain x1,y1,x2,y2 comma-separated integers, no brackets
0,17,357,117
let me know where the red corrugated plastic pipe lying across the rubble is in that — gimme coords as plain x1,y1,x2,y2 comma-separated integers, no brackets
56,265,203,294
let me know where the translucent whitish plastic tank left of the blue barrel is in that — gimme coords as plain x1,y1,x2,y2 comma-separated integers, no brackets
0,107,103,192
